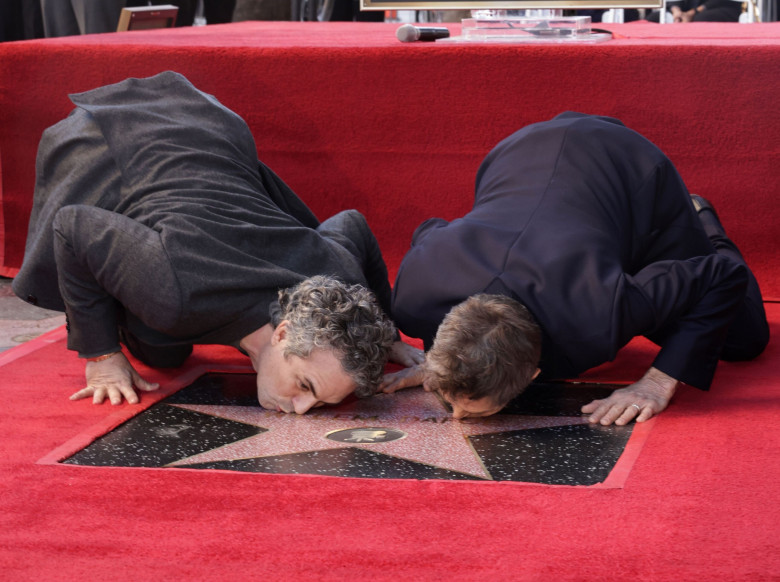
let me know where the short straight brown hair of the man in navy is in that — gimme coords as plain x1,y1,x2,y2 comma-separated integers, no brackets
425,294,542,407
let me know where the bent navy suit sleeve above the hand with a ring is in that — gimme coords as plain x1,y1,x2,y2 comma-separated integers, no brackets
620,254,748,390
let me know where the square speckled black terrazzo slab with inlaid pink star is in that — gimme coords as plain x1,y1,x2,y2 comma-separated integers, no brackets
63,374,632,485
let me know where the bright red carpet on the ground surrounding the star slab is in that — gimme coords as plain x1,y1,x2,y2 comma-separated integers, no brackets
0,304,780,582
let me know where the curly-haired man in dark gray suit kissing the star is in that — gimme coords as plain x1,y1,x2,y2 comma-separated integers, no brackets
13,72,421,413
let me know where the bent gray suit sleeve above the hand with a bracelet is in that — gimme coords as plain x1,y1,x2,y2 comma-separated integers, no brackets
53,205,181,358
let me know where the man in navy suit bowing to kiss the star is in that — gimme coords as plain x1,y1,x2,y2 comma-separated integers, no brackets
384,113,769,425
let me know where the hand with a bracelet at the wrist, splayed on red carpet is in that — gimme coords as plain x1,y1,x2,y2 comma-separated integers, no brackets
70,353,160,404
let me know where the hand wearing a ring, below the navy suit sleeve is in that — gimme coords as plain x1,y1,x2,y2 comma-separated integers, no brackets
582,368,679,426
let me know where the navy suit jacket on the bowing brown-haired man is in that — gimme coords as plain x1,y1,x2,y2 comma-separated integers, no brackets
392,113,747,389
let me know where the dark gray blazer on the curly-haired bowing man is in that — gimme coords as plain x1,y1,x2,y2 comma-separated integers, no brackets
13,72,390,357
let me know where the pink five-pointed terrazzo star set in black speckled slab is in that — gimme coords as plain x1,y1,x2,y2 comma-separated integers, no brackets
169,389,586,479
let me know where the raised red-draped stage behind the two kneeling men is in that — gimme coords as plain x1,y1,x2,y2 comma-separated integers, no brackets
0,22,780,298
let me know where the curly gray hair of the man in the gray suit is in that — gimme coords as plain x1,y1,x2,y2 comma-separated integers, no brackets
273,275,396,398
